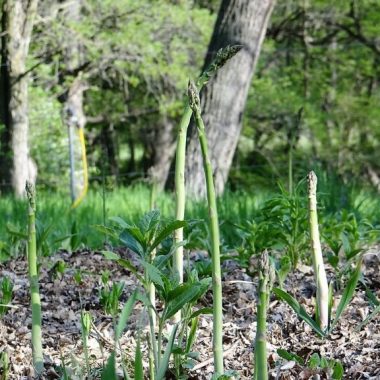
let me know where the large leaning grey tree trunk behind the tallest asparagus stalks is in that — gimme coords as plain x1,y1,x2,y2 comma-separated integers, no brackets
186,0,275,197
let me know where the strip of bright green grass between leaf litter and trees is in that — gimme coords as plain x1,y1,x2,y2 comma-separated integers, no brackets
0,180,380,258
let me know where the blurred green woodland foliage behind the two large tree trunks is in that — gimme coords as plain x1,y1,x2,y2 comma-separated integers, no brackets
0,0,380,199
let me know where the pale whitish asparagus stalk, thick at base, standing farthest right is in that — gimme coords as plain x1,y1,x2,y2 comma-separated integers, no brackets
307,171,329,330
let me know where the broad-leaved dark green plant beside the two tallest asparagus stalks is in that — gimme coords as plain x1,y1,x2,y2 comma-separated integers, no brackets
103,210,210,380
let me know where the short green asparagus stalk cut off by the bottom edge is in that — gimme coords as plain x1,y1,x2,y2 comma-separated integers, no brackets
255,251,275,380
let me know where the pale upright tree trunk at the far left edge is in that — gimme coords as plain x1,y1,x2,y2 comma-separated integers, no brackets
0,0,38,197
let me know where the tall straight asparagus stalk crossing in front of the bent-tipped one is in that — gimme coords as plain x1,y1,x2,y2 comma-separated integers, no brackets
188,82,224,375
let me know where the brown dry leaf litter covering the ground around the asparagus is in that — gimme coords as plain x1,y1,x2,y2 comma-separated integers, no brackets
0,247,380,380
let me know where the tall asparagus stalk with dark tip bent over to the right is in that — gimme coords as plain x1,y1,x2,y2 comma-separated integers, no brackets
173,45,241,322
